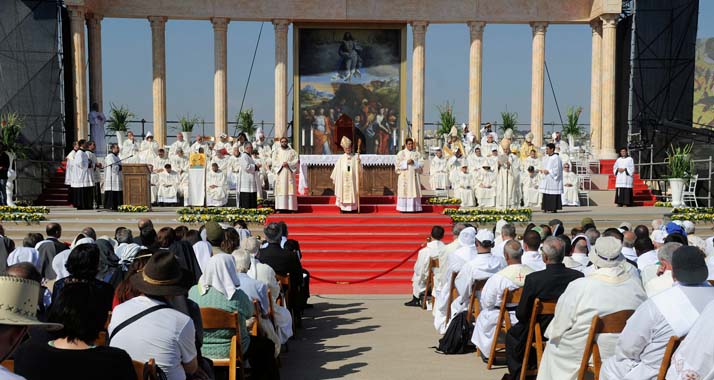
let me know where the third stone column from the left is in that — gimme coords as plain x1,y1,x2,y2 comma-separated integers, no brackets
149,16,167,147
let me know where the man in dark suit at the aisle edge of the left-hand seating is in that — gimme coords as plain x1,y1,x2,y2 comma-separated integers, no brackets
256,223,303,320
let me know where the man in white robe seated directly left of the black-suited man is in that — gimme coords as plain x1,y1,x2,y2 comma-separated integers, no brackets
471,240,533,356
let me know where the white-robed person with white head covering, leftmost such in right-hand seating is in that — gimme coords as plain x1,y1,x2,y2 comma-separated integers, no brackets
433,227,478,334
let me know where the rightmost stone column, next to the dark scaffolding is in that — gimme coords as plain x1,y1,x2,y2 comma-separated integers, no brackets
600,14,620,159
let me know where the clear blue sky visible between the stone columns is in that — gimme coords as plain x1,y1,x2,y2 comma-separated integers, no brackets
102,1,714,137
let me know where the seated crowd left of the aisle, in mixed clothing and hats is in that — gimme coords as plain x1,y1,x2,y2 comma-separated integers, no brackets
0,219,310,380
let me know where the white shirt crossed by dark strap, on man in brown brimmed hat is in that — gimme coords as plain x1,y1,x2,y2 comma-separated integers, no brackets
109,296,197,380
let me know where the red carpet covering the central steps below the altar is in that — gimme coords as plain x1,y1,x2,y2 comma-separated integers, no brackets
266,196,452,294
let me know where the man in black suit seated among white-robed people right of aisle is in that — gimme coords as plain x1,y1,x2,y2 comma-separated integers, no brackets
504,236,583,379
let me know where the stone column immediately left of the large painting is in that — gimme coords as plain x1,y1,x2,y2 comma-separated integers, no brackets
273,20,288,141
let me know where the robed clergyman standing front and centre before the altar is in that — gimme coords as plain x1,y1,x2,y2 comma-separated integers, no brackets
330,136,362,211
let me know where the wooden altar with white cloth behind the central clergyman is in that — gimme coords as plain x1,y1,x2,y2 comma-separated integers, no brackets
298,154,397,195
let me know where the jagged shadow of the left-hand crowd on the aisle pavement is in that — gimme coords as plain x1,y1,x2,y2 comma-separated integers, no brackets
281,298,380,379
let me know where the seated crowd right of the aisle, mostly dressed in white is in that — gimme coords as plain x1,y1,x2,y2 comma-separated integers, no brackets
405,218,714,380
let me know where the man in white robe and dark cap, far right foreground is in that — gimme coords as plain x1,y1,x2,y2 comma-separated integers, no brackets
600,243,714,380
